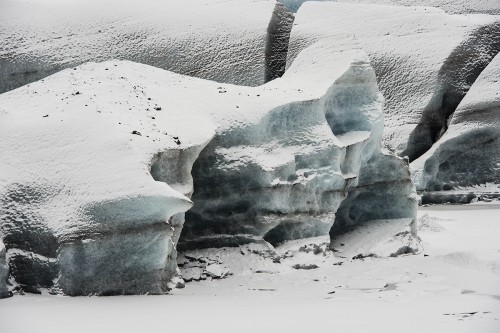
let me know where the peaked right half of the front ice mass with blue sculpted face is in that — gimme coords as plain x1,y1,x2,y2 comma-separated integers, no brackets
180,42,416,249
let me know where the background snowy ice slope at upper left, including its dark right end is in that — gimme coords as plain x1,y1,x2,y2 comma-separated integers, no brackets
0,0,292,93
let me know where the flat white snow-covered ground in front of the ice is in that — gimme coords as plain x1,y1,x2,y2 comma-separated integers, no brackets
0,201,500,333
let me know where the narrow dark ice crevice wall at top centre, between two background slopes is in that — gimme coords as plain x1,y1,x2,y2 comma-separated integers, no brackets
265,3,295,82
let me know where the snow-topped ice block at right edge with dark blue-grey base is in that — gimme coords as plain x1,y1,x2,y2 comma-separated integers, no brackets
411,55,500,201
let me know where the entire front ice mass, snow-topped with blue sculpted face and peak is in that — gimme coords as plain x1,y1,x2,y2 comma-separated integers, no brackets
0,42,417,295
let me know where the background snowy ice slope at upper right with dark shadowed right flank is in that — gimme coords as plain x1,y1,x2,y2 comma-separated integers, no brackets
287,2,500,160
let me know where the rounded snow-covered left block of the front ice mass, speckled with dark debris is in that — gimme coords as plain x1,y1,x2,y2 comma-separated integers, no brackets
0,62,213,295
